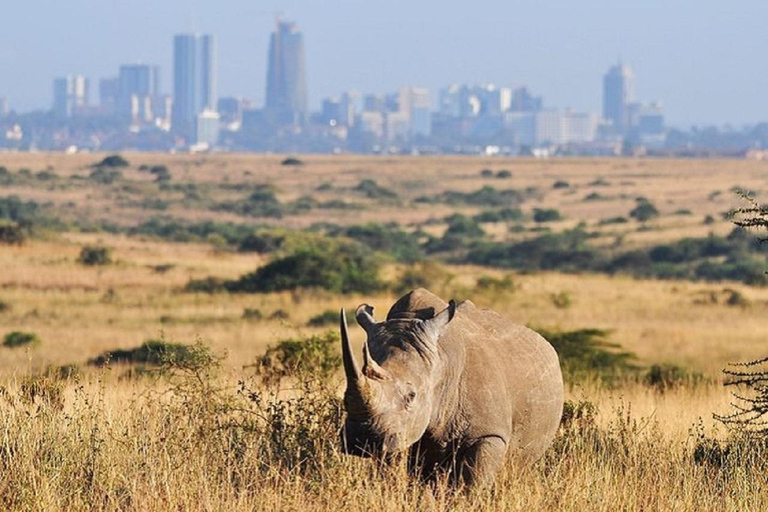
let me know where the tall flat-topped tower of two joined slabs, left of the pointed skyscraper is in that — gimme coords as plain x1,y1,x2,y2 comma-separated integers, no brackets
172,34,217,141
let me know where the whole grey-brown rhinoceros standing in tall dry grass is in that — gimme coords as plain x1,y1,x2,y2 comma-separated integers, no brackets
340,288,563,486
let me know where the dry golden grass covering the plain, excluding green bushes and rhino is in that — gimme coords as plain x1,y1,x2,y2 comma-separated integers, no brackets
0,154,768,510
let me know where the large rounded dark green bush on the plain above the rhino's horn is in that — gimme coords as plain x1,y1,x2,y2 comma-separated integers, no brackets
225,240,383,293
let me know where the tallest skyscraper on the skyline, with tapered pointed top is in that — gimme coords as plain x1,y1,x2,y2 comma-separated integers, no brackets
265,21,307,126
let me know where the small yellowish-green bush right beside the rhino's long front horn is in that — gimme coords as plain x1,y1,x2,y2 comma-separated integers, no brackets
256,330,341,385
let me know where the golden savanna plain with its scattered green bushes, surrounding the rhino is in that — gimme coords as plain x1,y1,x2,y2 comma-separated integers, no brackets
0,153,768,511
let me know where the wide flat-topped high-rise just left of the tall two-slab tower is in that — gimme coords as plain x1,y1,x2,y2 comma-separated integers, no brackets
117,64,160,123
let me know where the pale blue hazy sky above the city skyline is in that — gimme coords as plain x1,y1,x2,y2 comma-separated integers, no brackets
0,0,768,127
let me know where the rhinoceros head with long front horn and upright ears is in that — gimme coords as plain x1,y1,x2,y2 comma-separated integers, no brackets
340,301,456,457
